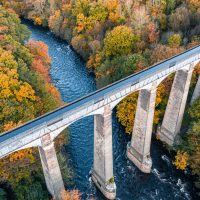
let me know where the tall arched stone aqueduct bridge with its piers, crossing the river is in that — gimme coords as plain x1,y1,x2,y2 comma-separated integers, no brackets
0,46,200,200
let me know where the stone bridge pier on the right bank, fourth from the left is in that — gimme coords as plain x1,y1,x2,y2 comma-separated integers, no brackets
157,65,193,145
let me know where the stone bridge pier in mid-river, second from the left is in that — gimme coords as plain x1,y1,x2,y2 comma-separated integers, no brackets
92,106,116,199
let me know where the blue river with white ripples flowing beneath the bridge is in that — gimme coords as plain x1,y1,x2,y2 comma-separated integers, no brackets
24,21,197,200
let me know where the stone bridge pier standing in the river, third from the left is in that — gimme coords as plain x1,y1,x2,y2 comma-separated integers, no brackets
127,86,156,173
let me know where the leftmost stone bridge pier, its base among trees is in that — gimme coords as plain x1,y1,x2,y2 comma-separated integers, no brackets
38,134,65,200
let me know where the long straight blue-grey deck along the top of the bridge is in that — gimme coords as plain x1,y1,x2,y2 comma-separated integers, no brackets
0,45,200,143
